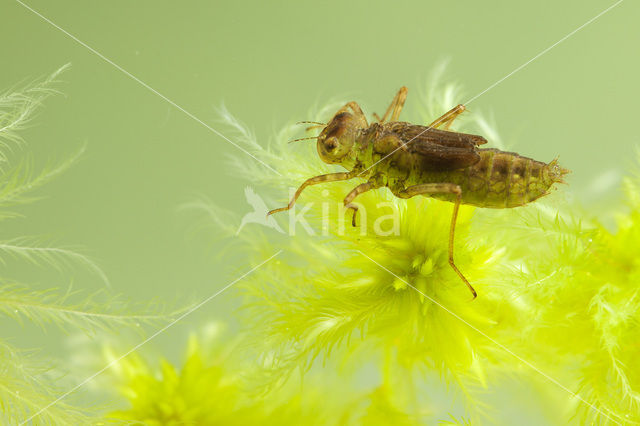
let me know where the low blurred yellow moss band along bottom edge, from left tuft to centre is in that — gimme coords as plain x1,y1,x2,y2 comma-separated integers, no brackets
107,323,429,426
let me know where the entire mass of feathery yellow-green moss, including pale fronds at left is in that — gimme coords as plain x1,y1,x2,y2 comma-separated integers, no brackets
0,67,640,425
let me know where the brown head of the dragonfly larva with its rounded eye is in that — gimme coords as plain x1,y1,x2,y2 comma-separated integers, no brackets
318,110,366,164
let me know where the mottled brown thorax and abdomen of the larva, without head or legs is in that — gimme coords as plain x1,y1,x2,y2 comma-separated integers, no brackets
349,123,566,209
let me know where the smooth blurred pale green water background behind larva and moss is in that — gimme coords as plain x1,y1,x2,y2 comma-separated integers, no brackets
0,0,640,392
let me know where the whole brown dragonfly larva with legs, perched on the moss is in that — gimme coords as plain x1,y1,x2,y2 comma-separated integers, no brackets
268,87,569,298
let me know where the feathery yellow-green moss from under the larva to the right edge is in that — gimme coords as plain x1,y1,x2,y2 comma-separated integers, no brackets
189,68,640,424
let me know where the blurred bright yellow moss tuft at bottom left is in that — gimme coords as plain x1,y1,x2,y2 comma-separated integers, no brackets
107,325,255,425
